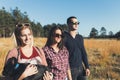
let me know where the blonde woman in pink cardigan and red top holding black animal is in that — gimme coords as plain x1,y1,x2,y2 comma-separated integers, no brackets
2,23,52,80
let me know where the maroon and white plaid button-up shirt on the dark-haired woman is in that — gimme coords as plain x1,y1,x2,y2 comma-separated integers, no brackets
43,46,70,80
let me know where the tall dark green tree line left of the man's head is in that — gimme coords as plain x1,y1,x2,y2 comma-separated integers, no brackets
0,7,67,37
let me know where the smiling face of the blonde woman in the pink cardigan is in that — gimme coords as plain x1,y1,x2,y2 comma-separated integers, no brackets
20,28,33,46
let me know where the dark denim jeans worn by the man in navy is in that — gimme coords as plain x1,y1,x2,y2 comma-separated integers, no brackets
71,67,87,80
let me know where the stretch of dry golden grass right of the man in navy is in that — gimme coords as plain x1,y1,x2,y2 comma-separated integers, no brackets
85,39,120,80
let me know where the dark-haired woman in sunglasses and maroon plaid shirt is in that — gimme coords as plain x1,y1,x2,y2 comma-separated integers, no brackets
43,26,72,80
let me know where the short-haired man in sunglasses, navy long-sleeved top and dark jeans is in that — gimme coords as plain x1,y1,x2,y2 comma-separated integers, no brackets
64,16,90,80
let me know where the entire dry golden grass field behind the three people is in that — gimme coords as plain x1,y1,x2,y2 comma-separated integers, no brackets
0,37,120,80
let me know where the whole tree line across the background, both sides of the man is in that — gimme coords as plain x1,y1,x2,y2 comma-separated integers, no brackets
0,7,120,38
